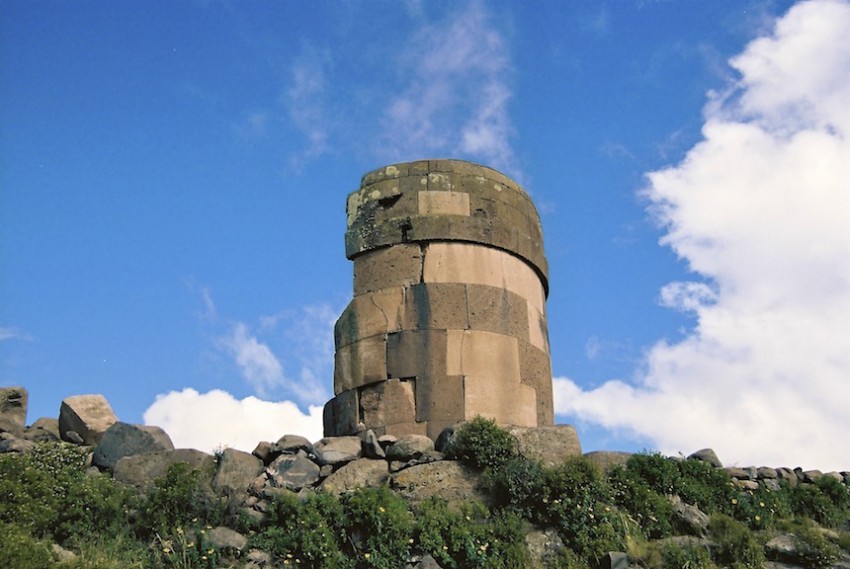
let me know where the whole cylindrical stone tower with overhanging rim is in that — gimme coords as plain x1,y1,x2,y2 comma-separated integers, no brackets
324,160,554,438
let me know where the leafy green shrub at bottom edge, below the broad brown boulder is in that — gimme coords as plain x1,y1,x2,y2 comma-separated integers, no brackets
414,498,528,569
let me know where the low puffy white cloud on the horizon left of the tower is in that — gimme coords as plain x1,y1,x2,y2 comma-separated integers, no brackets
144,389,322,452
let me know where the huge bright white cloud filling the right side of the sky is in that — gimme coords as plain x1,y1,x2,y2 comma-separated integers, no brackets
555,0,850,469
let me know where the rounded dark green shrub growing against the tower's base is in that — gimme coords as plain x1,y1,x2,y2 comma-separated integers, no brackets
447,416,517,470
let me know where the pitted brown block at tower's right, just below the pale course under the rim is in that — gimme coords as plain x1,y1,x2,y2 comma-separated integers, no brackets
466,285,528,341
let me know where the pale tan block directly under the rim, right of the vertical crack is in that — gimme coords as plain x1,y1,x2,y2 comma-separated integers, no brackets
422,243,505,287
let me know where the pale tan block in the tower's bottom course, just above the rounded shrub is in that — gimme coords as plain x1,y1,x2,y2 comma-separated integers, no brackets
463,375,537,427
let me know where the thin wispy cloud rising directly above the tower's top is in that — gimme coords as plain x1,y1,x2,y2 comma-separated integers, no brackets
382,2,515,170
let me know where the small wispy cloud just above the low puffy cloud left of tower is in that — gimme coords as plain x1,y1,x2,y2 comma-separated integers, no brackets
219,322,285,397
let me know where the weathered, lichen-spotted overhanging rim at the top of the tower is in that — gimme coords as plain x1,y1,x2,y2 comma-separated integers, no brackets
345,160,549,291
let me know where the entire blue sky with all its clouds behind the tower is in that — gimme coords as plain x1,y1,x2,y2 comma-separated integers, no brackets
0,0,850,469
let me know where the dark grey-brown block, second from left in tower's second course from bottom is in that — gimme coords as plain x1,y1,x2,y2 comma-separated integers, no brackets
387,330,447,379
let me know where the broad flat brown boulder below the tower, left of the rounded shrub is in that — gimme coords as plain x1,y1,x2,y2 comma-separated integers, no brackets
390,460,487,509
